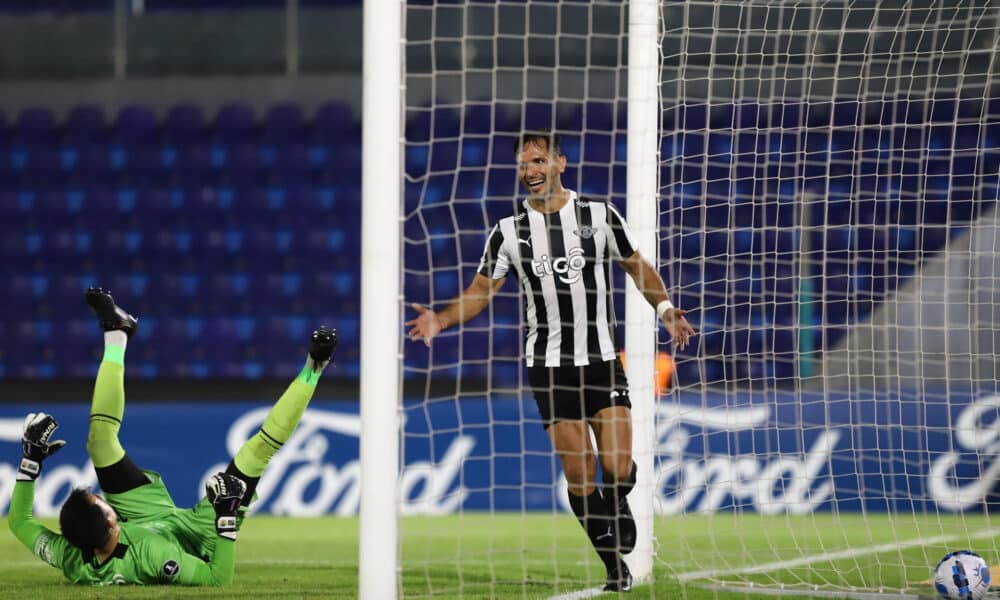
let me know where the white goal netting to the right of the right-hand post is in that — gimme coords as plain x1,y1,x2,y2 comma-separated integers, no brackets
658,0,1000,593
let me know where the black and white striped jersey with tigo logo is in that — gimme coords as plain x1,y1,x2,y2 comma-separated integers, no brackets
479,191,636,367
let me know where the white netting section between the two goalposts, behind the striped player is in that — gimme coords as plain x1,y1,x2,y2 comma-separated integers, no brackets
401,2,640,597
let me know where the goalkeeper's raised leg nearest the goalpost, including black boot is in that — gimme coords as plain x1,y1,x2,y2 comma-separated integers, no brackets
226,326,337,506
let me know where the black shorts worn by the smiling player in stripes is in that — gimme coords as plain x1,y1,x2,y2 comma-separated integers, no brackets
528,358,632,429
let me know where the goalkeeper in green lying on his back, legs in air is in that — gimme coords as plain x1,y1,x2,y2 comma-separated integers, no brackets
8,288,337,585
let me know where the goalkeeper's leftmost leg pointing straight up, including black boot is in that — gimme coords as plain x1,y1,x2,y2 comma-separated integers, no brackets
84,288,149,494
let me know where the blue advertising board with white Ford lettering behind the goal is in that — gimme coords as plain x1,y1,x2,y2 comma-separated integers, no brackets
0,390,1000,515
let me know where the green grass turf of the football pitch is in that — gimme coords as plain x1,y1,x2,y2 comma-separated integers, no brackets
0,514,1000,600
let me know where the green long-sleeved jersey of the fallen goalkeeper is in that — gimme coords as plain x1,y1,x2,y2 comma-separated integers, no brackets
7,477,236,585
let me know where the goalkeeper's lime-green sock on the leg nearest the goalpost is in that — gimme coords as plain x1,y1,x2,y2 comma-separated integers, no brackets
233,358,322,477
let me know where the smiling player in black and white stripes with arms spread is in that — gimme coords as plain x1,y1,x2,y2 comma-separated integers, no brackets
406,131,695,591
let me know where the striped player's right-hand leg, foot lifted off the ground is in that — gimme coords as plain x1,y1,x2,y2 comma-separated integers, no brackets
585,360,636,554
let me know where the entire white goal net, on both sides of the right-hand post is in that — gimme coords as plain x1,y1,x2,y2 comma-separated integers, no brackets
387,0,1000,598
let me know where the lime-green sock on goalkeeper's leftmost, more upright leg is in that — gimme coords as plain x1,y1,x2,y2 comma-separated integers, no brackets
87,331,126,468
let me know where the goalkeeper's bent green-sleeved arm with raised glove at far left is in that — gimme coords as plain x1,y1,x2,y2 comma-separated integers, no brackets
7,413,68,567
